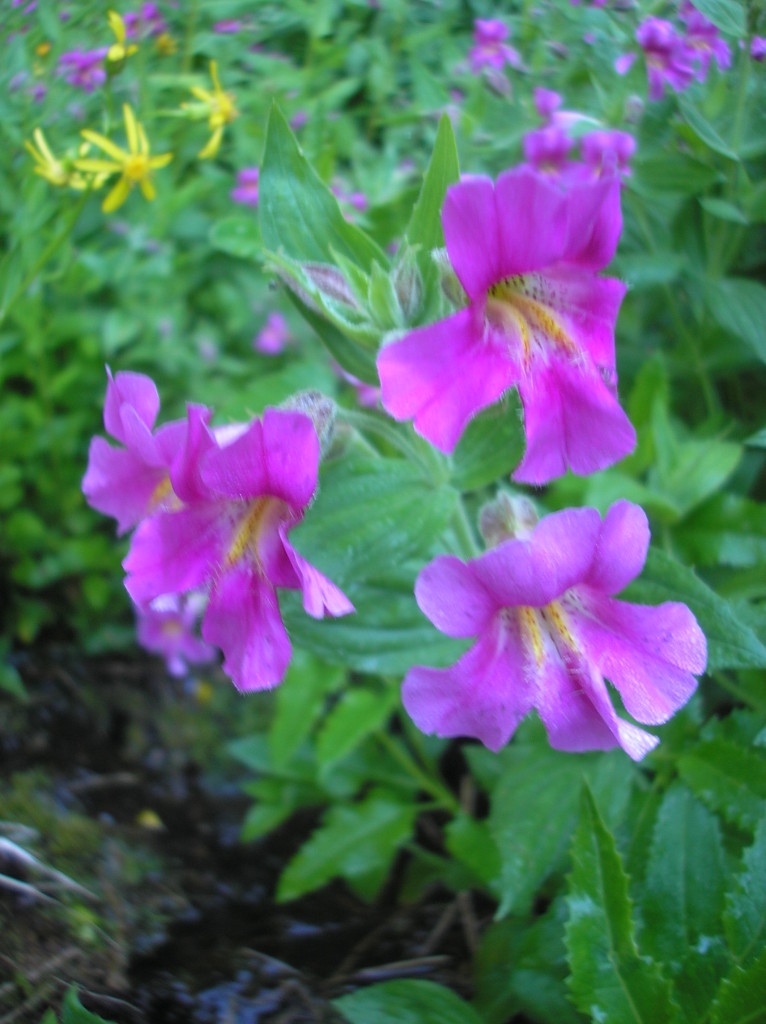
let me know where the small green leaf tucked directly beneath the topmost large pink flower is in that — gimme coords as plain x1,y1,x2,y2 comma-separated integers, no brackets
452,391,524,492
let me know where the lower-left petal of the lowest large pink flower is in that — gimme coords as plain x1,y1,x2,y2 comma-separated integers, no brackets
401,615,535,751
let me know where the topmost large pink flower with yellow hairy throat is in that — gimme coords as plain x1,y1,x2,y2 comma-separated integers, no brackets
378,166,636,483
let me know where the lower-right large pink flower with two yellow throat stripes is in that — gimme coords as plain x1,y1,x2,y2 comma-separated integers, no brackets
402,501,707,760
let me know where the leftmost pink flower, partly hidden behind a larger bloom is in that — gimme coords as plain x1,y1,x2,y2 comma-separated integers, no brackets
82,367,186,535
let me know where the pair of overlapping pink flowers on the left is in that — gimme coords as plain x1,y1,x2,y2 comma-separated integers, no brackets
83,371,353,690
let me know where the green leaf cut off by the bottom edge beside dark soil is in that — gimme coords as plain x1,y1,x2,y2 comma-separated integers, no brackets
333,979,484,1024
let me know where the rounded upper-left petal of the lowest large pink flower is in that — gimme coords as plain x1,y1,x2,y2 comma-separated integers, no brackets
415,555,498,637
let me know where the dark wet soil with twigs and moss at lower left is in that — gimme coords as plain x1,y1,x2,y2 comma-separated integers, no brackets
0,650,477,1024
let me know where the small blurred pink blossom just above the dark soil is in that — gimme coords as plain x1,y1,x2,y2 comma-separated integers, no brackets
135,594,215,678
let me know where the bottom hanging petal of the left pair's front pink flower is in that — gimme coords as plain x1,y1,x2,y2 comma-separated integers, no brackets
202,565,292,691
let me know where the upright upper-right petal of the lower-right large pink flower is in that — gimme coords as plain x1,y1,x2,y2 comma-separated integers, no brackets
584,501,649,594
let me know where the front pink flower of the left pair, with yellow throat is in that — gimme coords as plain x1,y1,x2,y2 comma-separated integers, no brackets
124,406,353,690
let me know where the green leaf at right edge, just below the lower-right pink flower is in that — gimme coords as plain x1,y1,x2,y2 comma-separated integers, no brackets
678,739,766,830
